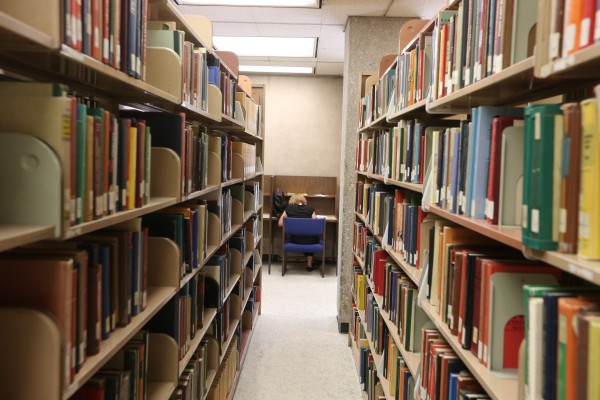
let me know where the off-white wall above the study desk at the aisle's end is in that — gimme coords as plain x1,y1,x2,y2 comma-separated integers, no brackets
250,75,342,176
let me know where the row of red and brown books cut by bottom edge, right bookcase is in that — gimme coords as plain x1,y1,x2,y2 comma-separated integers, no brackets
416,328,490,400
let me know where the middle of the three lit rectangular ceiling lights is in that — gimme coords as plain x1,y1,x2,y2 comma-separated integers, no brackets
213,36,317,57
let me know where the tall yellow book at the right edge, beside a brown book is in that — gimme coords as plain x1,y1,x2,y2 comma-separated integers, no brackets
578,98,600,259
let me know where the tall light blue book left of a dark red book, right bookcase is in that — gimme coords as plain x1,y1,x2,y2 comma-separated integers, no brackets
467,106,524,219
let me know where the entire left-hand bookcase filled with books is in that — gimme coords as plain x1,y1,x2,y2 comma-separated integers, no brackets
0,0,264,400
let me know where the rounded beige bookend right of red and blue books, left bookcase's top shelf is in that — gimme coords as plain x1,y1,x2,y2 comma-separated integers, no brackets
146,47,183,104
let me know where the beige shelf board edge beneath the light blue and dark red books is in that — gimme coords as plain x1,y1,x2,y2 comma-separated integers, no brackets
429,206,522,250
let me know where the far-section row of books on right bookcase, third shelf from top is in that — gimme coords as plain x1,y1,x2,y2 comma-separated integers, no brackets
355,180,427,267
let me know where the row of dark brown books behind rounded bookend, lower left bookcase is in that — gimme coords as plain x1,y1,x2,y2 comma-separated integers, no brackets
0,218,148,386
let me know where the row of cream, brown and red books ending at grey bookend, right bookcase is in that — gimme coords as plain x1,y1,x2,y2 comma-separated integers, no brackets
420,216,568,374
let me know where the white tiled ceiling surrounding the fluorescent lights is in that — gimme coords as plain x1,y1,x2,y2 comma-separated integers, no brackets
178,0,445,76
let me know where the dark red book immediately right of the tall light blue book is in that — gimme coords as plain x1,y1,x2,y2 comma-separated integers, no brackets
485,117,523,225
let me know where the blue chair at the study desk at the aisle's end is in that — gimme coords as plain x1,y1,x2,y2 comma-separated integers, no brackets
281,218,325,277
